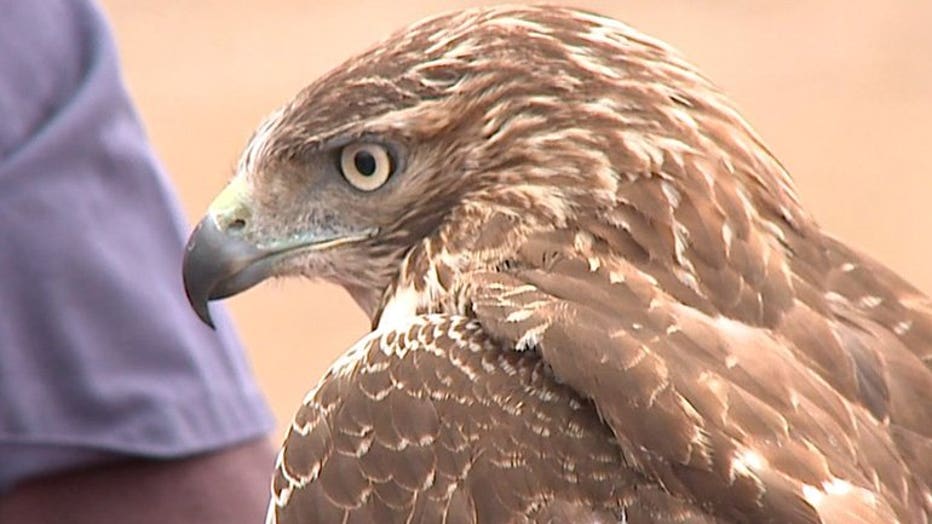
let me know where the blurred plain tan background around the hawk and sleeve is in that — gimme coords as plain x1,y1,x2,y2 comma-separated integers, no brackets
98,0,932,440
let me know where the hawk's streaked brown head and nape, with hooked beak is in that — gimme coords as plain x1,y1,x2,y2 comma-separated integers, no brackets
184,7,796,328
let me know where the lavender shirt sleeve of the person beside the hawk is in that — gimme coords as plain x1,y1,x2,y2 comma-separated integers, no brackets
0,0,271,491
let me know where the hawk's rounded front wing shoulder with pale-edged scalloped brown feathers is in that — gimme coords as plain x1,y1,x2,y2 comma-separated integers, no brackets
269,315,714,523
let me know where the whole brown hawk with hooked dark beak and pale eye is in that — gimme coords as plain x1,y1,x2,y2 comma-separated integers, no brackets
184,6,932,523
